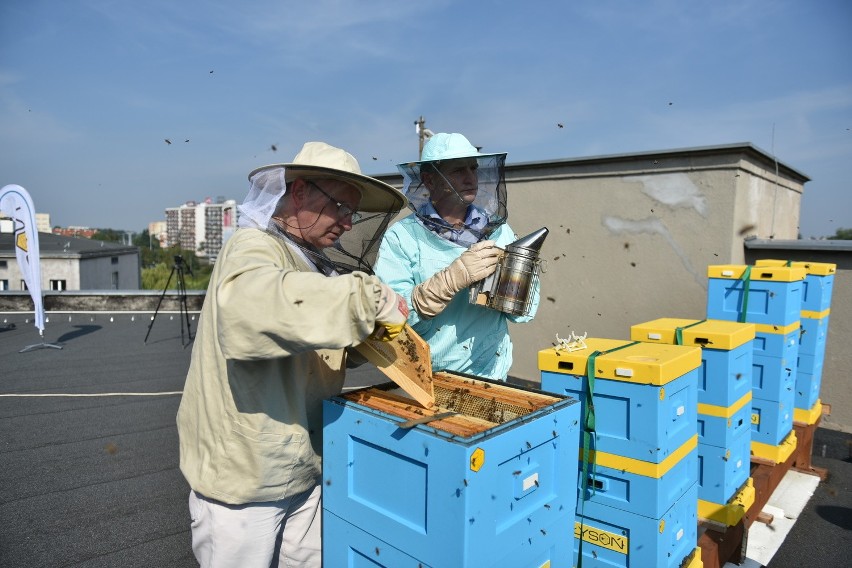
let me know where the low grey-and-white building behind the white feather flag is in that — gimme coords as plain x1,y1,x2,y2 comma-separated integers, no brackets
0,231,141,291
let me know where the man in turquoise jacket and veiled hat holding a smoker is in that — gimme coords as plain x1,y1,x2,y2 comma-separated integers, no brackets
374,133,539,380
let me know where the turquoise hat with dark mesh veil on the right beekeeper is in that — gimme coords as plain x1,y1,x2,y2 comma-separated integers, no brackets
397,132,508,246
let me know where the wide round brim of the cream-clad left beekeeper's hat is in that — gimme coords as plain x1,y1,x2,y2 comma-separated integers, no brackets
249,164,408,213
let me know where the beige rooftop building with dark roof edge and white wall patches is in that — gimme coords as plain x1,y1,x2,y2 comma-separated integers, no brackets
507,144,808,380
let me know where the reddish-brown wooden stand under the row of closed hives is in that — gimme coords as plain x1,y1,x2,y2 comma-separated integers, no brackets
698,404,831,568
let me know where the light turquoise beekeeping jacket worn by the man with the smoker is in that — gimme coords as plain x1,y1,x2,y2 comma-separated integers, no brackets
373,214,539,380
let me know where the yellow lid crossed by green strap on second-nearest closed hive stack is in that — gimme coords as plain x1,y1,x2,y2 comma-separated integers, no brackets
630,318,757,351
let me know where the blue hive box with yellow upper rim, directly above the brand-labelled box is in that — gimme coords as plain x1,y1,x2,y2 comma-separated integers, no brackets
579,435,698,518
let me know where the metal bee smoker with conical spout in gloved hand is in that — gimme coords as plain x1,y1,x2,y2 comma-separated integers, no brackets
469,227,548,316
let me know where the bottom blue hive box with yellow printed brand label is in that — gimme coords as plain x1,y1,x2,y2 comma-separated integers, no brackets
574,484,698,568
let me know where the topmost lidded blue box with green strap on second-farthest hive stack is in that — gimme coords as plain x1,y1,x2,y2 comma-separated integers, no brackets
707,264,805,326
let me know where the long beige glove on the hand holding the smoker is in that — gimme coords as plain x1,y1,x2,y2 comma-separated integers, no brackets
411,241,503,318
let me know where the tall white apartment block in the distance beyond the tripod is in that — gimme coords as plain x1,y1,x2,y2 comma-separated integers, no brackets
166,197,237,262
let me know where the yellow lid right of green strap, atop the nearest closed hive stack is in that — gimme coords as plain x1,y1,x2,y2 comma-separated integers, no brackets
595,343,701,385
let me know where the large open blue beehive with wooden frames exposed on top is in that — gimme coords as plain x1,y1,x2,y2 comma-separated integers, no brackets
323,373,580,568
